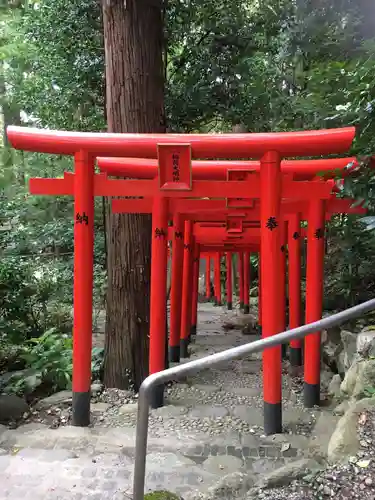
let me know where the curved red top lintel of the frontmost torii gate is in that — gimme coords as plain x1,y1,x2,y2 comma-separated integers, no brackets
7,126,355,159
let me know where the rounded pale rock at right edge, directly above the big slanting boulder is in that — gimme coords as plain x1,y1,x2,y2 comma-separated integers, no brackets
341,359,375,399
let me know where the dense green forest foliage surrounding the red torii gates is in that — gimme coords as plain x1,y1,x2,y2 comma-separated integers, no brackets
0,0,375,398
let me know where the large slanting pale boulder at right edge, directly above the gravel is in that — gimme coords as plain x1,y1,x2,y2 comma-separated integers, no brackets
328,398,375,463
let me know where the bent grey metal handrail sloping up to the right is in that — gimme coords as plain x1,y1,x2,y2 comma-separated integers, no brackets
133,299,375,500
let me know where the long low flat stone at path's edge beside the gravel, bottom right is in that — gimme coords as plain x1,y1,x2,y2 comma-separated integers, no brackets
257,458,322,488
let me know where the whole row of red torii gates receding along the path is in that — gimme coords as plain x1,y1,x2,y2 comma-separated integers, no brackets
7,126,364,434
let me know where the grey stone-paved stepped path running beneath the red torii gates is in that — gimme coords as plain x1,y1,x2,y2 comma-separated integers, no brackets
0,303,339,500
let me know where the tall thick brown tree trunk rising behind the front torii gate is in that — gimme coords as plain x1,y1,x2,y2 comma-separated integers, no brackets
103,0,165,389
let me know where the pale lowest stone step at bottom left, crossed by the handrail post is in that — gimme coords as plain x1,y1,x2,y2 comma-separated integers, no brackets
0,448,221,500
